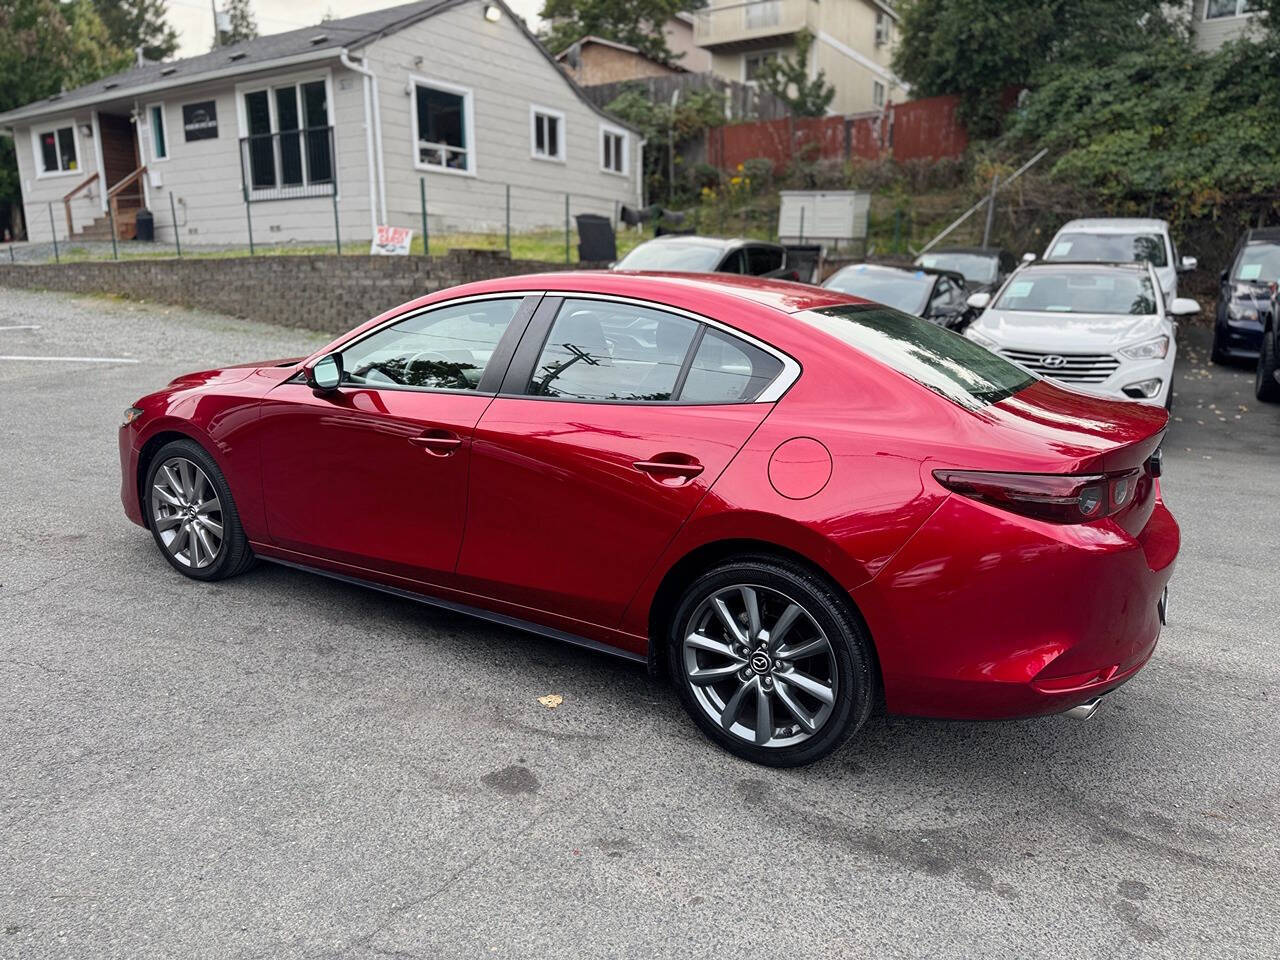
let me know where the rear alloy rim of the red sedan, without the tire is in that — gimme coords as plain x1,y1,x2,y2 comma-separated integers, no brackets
682,584,838,748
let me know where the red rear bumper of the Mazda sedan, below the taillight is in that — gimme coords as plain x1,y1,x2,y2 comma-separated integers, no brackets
852,497,1180,719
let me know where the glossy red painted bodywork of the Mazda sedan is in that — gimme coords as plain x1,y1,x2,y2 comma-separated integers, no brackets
120,273,1179,718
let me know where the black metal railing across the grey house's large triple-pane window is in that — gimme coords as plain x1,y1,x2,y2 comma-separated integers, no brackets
241,127,335,201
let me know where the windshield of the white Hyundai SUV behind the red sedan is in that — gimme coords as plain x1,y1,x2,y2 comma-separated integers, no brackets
993,266,1156,315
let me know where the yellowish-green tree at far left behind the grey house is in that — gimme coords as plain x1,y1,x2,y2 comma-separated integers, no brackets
0,0,132,239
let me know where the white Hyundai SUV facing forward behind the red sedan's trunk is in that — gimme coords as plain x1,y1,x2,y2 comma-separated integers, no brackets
964,262,1199,407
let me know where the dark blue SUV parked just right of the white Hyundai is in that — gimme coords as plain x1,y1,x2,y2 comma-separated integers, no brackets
1213,227,1280,364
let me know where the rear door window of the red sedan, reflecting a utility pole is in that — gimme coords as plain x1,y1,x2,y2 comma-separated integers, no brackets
527,300,699,402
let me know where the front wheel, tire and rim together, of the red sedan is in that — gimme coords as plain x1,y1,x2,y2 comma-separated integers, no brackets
142,440,253,580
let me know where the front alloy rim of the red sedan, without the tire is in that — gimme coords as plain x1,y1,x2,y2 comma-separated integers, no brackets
151,457,223,570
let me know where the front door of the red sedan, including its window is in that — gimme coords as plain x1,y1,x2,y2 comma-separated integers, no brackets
261,297,538,584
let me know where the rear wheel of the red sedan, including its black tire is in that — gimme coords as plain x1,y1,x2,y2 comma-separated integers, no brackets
667,557,877,767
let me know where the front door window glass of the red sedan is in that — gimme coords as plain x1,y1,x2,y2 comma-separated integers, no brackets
342,297,521,390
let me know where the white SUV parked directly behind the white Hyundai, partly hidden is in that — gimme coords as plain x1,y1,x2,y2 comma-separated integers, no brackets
1044,216,1199,303
